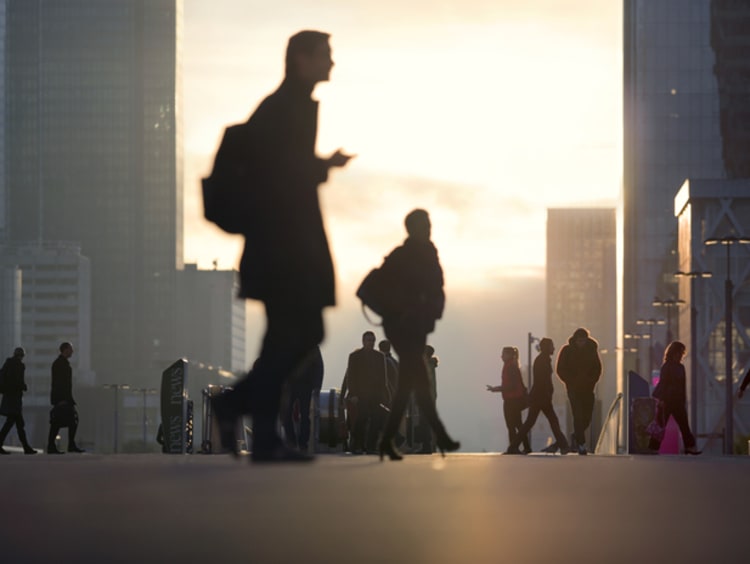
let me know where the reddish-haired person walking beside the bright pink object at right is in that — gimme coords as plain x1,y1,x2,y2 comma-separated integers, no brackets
648,341,701,454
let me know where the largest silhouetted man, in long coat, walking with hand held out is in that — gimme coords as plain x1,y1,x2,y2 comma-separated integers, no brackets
214,31,351,462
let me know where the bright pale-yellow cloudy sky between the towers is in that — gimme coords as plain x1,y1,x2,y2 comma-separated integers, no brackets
183,0,622,450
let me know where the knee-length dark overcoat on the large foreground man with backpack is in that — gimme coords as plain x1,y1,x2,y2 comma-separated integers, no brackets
236,79,335,308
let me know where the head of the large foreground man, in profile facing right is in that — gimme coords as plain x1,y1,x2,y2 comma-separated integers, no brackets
286,30,333,84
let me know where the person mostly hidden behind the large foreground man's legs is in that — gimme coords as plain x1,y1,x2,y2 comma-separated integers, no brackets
284,347,324,452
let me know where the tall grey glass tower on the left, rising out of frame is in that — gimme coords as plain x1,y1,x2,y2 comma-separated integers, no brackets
4,0,183,385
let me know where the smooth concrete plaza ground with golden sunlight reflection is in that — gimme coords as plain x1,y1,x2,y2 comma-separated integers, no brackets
0,454,750,564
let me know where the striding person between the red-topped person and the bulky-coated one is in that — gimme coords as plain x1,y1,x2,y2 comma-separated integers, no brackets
508,337,569,454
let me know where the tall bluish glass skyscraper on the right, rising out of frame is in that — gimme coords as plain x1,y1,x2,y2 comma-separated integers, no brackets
621,0,732,356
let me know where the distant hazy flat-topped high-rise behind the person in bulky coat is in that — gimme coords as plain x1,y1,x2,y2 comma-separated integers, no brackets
546,208,617,446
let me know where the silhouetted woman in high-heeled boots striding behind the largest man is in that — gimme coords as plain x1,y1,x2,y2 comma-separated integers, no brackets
380,209,461,460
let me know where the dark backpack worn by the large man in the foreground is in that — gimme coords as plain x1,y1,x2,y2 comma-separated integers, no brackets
202,123,251,233
